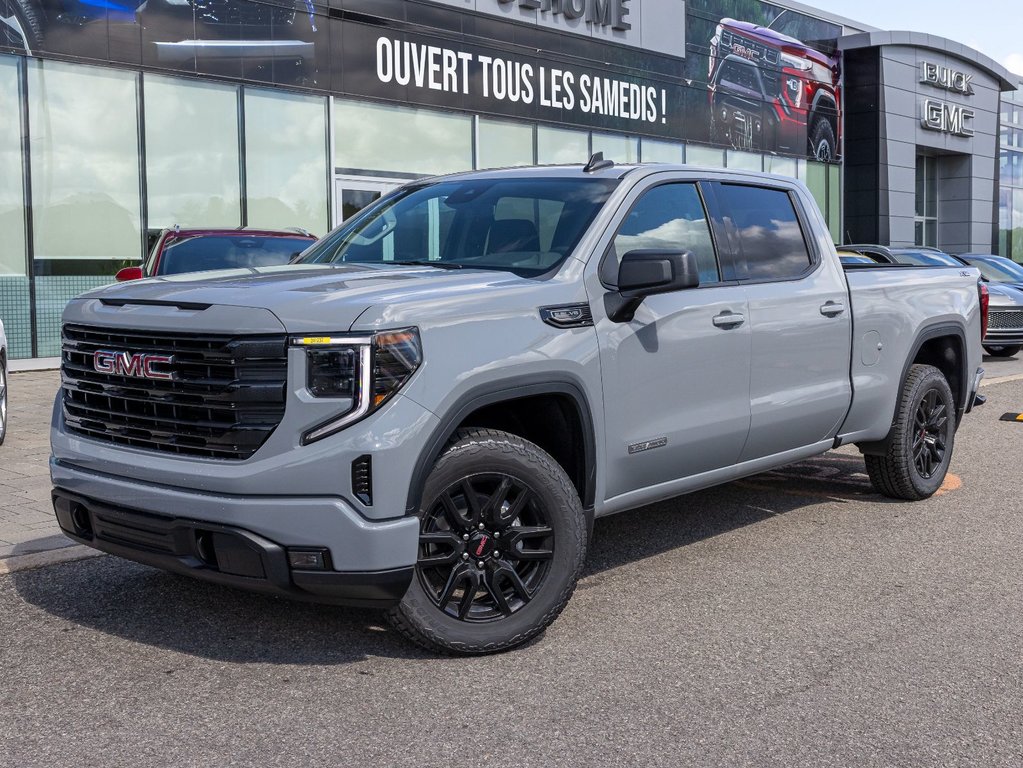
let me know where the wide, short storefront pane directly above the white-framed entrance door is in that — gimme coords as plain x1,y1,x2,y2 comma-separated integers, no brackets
333,99,473,176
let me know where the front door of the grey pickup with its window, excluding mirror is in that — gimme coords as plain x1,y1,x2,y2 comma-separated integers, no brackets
591,177,750,499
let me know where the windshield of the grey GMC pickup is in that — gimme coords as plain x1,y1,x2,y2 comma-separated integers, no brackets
299,178,618,277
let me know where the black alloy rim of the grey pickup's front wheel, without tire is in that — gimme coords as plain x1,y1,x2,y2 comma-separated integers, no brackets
416,472,554,622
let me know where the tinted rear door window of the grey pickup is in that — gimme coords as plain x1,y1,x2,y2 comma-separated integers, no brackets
718,184,812,280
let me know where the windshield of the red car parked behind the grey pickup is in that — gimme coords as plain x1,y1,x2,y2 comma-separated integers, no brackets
157,239,313,275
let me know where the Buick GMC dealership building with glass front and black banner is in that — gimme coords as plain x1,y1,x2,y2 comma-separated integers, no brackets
0,0,1023,358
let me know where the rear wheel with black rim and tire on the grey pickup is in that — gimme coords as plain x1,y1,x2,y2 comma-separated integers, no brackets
864,365,955,501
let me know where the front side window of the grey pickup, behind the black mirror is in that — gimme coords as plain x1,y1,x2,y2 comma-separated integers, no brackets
614,183,721,284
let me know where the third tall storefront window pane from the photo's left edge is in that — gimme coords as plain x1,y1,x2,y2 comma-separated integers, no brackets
144,75,241,228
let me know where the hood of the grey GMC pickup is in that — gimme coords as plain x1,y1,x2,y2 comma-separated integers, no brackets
80,264,536,333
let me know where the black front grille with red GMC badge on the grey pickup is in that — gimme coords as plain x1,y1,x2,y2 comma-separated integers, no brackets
60,325,287,460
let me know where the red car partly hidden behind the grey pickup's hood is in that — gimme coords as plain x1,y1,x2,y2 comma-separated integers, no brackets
117,227,316,282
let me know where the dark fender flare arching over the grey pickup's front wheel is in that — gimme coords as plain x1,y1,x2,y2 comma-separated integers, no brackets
405,373,596,529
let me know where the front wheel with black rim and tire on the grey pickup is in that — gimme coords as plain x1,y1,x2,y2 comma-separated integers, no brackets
387,430,586,654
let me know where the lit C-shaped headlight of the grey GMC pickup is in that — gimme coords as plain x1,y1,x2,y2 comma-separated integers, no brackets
292,328,422,445
